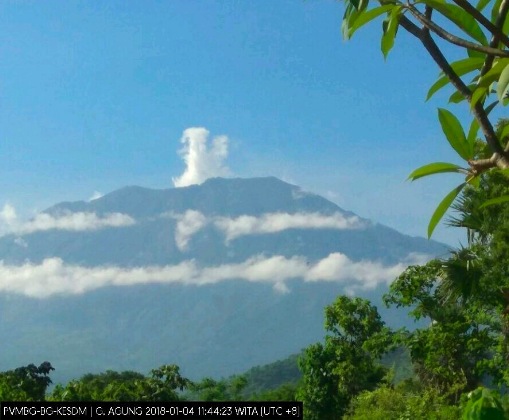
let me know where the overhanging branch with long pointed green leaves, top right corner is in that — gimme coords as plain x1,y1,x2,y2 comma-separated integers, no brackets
342,0,509,236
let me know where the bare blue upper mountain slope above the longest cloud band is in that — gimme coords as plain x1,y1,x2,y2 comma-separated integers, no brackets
0,178,445,266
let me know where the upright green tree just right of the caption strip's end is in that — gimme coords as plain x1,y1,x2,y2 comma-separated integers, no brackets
297,296,391,420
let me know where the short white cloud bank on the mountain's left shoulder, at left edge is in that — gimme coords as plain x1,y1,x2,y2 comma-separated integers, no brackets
0,204,136,235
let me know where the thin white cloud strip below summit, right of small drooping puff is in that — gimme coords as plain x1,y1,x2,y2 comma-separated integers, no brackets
214,213,365,241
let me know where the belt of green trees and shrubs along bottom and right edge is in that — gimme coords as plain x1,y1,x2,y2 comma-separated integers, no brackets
0,167,509,420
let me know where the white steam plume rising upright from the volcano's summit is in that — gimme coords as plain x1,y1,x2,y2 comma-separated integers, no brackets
173,127,230,187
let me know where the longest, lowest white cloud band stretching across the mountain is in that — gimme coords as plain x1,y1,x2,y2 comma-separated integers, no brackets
0,249,420,298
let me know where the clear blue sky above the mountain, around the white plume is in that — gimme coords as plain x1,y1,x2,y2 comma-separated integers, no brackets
0,0,464,245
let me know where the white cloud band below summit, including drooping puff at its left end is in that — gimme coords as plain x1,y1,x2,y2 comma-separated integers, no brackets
170,210,365,251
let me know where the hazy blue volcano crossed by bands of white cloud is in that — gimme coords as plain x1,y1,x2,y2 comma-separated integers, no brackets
0,177,447,381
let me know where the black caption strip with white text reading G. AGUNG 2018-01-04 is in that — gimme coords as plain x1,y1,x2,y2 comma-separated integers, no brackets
0,401,303,420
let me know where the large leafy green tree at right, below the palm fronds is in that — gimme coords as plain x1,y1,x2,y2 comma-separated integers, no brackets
384,258,500,402
